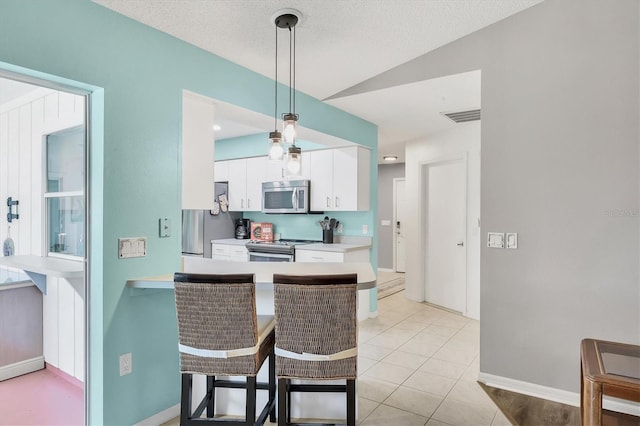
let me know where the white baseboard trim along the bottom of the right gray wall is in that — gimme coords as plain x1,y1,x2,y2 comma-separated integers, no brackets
478,372,640,416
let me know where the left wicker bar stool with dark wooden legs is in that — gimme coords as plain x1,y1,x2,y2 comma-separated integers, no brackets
174,272,276,426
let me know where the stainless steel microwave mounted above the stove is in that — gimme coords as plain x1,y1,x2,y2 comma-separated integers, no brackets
262,180,309,213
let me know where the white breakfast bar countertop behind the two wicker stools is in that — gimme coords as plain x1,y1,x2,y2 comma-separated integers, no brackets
127,257,376,290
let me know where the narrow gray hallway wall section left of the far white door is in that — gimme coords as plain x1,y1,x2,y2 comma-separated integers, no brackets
377,163,404,269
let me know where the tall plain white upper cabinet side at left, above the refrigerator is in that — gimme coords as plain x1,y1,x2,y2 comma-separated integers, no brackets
182,91,214,210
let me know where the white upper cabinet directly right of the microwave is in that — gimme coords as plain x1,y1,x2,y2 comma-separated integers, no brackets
310,146,371,211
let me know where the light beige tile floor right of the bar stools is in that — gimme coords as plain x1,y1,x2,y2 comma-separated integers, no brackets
167,291,510,426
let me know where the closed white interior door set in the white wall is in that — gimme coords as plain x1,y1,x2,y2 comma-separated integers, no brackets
425,158,467,313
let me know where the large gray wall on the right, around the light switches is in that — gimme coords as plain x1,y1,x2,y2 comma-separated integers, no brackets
343,0,640,392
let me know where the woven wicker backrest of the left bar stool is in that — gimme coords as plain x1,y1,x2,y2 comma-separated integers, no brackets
174,273,268,376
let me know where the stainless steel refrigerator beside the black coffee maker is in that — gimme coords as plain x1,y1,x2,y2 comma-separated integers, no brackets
182,182,242,257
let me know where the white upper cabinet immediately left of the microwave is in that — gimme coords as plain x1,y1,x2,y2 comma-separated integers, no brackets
228,157,267,212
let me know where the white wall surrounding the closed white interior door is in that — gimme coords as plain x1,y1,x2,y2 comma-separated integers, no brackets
405,121,481,319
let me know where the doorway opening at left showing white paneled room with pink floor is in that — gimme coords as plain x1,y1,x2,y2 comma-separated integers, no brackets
0,70,90,425
